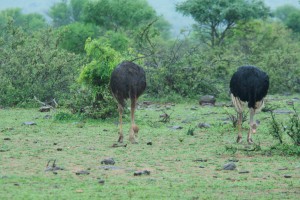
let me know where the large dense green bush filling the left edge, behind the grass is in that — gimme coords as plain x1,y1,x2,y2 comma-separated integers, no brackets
0,23,82,106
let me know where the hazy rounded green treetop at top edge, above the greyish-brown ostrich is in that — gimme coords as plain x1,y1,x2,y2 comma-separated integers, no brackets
84,0,168,31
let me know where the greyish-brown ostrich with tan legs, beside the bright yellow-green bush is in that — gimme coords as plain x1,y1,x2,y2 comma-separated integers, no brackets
110,61,146,143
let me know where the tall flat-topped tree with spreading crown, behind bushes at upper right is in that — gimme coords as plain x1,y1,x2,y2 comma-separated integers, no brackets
176,0,269,47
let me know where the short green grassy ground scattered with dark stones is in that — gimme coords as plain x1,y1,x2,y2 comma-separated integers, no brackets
0,95,300,199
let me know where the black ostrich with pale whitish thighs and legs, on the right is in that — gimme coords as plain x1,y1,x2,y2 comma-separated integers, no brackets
230,66,269,143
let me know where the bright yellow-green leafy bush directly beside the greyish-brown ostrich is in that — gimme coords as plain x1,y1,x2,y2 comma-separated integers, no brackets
77,38,123,118
